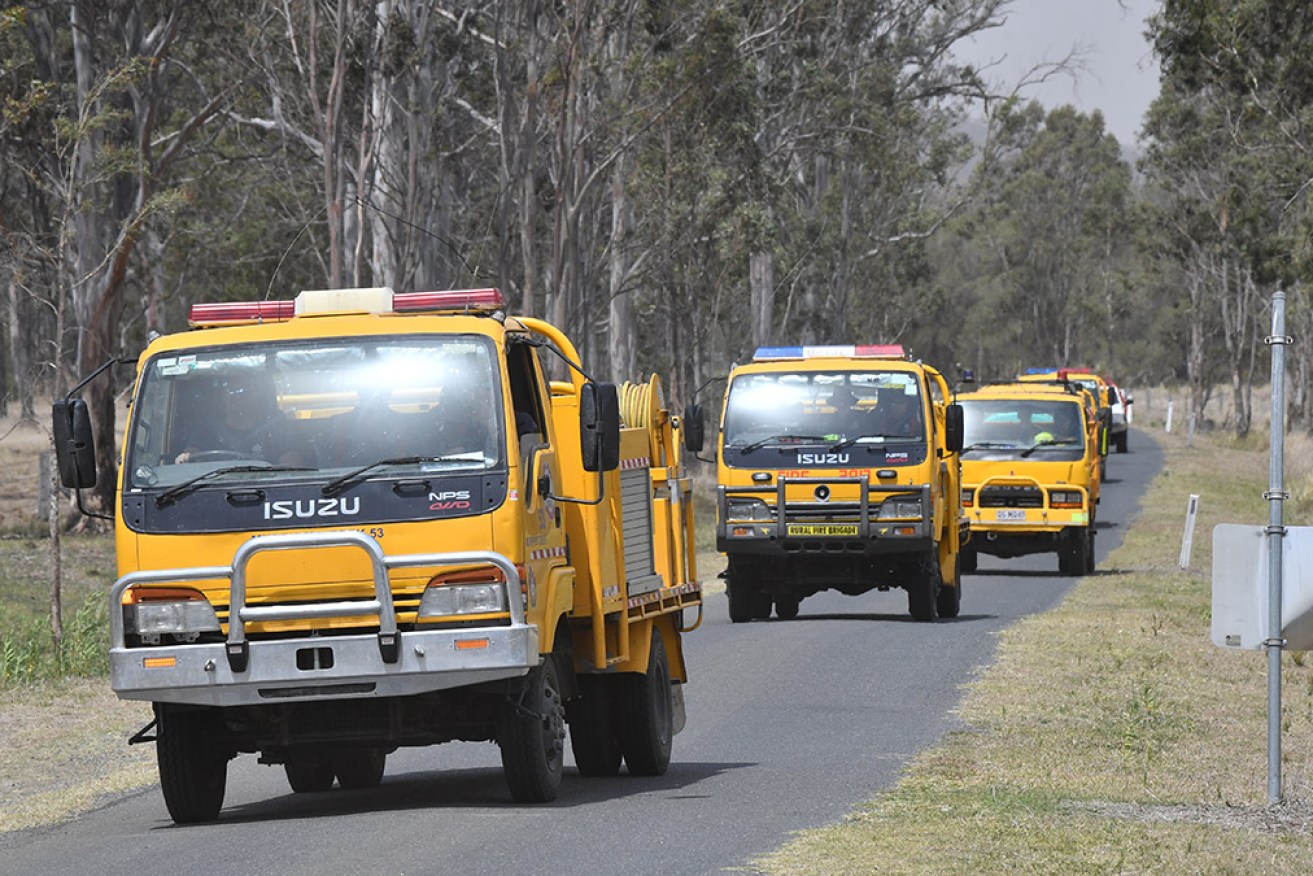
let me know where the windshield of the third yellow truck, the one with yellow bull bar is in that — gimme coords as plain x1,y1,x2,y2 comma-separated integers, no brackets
958,398,1086,461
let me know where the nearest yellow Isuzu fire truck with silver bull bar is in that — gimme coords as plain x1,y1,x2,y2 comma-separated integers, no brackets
54,289,701,823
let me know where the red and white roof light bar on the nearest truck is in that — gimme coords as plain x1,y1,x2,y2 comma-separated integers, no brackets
186,286,506,328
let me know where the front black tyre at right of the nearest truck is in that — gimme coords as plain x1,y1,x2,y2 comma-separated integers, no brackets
498,657,566,802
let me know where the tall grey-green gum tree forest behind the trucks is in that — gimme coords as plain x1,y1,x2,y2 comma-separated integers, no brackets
0,0,1313,504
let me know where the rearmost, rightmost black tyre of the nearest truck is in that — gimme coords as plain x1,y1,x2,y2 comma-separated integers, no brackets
620,626,675,776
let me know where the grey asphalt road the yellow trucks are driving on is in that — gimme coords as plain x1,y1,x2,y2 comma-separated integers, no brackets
0,431,1162,876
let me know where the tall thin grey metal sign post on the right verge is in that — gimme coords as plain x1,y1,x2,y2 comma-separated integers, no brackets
1263,289,1292,804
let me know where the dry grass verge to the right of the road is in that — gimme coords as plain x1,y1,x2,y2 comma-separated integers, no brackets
758,436,1313,876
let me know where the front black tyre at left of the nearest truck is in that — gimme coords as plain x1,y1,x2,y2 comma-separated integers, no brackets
155,704,228,825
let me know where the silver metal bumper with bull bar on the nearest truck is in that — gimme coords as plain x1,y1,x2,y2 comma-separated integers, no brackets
109,531,538,705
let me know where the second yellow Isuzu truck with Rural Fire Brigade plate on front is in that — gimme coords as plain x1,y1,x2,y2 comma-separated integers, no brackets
716,345,968,623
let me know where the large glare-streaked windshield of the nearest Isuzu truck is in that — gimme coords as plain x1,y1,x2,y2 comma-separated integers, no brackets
125,335,504,490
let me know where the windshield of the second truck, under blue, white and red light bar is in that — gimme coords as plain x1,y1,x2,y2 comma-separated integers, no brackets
723,370,926,464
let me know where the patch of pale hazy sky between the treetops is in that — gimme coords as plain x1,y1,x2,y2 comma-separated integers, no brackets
953,0,1159,146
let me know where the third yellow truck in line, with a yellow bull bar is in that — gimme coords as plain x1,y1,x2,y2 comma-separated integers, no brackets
957,381,1102,575
